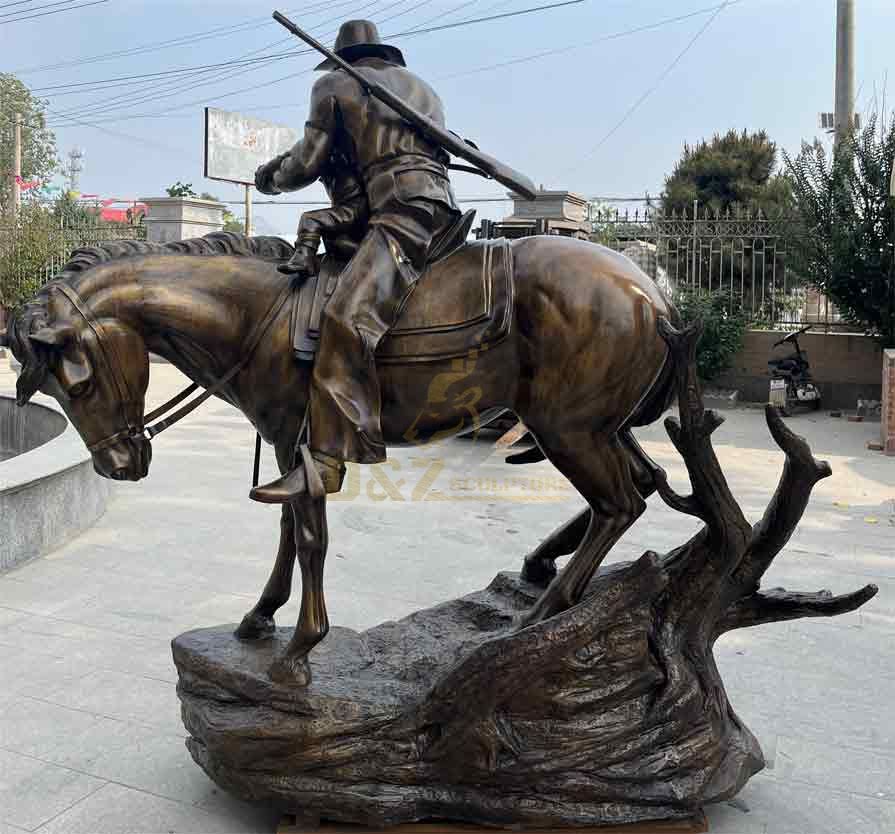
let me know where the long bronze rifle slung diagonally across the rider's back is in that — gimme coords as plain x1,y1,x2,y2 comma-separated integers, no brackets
273,12,537,200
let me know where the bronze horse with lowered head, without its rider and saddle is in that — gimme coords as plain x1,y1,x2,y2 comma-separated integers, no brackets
0,234,677,684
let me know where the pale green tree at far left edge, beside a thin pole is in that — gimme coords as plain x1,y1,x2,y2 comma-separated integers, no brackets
0,73,59,214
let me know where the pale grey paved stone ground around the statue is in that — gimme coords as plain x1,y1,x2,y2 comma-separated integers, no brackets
0,360,895,834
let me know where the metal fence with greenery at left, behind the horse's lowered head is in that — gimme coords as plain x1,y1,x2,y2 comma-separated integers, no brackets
0,213,146,306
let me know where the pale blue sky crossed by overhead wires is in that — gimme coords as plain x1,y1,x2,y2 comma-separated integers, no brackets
0,0,895,236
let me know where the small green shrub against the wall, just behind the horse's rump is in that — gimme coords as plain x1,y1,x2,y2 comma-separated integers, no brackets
674,289,749,382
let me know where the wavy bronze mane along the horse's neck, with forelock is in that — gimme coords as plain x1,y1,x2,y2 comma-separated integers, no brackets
6,232,294,405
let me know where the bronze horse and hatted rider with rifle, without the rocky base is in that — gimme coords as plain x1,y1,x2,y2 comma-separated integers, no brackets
0,11,677,684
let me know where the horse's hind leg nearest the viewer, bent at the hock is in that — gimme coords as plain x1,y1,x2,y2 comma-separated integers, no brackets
522,433,646,625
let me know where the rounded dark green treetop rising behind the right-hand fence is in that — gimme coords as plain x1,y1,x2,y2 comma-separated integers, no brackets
662,130,790,214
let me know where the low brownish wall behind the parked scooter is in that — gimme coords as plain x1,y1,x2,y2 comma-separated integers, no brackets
712,330,882,409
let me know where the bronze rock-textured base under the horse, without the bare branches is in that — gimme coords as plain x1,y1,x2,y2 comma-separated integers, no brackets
174,554,763,828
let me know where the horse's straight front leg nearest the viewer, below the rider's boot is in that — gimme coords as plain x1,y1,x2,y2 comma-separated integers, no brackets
270,488,329,686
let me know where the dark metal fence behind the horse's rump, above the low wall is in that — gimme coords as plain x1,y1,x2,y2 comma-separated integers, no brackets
592,209,841,330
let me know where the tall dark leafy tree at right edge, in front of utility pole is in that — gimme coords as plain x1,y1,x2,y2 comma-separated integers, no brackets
784,113,895,346
